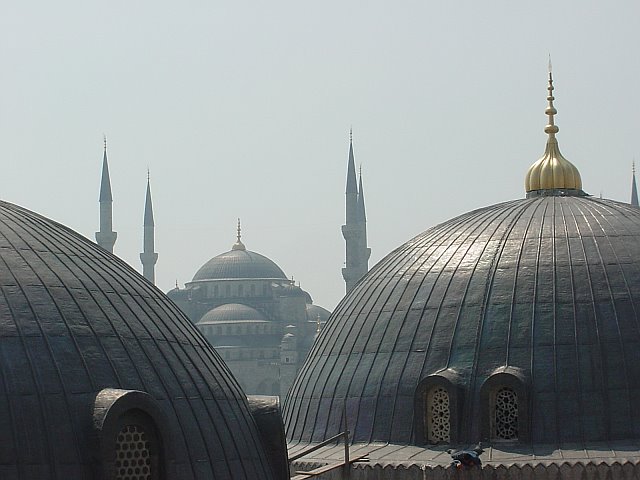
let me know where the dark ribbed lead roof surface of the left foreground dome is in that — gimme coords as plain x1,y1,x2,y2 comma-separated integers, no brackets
0,202,272,480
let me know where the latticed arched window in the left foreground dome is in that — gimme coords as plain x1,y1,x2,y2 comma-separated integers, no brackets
115,425,153,480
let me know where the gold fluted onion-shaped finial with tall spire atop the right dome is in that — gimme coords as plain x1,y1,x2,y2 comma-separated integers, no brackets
524,62,586,197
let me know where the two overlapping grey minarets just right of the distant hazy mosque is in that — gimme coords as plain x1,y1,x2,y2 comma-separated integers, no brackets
342,131,371,293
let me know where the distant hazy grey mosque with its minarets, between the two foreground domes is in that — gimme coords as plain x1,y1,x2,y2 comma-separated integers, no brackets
96,133,371,398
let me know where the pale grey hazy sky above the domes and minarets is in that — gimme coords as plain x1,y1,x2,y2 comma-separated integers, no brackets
0,0,640,309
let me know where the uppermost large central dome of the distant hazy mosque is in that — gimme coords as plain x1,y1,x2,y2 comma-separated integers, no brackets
193,250,287,281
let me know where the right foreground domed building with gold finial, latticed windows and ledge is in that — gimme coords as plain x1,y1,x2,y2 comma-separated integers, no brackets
283,72,640,480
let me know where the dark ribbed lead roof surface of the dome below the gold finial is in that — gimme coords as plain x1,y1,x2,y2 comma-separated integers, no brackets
284,196,640,445
